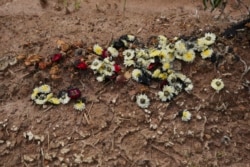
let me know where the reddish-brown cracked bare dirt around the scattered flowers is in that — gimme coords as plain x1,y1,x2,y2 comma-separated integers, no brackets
0,0,250,167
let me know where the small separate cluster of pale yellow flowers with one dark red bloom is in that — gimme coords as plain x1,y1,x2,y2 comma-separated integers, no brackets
31,84,85,111
